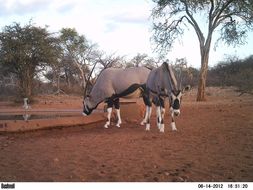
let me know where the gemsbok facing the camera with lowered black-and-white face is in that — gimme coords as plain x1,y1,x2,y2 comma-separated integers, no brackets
142,62,190,132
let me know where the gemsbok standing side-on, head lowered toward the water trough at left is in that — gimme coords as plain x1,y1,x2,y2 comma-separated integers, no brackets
83,67,151,128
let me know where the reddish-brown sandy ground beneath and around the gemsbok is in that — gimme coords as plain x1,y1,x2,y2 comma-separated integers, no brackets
0,88,253,182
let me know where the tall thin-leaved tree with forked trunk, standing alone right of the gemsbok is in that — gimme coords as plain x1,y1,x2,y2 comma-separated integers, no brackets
152,0,253,101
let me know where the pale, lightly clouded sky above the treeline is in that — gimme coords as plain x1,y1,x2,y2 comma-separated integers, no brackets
0,0,253,68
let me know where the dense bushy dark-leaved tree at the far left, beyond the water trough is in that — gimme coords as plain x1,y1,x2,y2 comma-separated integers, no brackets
0,23,59,98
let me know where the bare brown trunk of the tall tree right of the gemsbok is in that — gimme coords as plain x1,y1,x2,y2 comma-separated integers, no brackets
197,46,210,101
